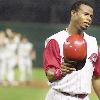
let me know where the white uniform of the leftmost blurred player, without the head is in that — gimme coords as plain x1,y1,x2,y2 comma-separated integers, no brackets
0,46,12,81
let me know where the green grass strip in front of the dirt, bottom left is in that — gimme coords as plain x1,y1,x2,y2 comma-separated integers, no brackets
0,87,47,100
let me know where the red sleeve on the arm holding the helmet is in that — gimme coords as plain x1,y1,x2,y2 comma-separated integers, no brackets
43,39,61,72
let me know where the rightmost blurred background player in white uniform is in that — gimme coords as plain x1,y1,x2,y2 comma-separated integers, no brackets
18,36,33,82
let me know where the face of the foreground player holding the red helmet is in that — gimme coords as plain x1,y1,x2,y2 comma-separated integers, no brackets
72,4,93,30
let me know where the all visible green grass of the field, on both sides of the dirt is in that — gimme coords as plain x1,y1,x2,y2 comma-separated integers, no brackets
0,69,98,100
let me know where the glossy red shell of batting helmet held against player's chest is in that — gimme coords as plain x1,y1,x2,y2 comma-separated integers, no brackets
63,34,87,61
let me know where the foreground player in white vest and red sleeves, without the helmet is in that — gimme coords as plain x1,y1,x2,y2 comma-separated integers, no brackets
43,1,100,100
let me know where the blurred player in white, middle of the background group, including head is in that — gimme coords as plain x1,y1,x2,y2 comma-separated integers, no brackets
6,29,20,85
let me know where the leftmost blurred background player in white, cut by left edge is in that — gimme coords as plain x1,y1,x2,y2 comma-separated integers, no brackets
0,32,13,84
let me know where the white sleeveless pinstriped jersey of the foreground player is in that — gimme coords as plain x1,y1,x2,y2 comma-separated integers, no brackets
45,30,98,94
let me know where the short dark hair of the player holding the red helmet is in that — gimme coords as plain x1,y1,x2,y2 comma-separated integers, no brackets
70,0,93,13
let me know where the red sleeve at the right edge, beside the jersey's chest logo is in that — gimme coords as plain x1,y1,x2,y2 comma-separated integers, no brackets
93,52,100,77
